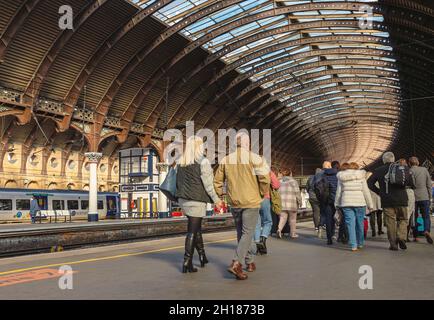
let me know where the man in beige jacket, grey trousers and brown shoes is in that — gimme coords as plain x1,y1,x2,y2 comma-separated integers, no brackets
214,133,270,280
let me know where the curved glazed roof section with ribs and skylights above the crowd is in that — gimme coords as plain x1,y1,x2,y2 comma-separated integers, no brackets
133,0,401,164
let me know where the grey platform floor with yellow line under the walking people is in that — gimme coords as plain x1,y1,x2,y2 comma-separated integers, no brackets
0,222,434,300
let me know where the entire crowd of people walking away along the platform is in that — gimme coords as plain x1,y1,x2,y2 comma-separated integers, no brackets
165,133,433,280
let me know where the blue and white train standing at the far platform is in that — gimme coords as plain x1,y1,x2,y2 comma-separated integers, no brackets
0,188,119,222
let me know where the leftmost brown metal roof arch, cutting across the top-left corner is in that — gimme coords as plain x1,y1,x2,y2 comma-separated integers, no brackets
0,0,40,63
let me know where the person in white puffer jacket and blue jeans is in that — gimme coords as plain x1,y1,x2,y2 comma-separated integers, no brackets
335,162,373,251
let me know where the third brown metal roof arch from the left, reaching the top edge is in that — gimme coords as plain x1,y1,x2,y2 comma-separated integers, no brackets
59,0,173,131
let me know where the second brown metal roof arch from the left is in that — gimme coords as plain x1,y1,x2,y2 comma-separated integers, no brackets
23,0,108,105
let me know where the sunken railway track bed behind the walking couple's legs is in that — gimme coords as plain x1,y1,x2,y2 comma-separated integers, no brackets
0,209,312,257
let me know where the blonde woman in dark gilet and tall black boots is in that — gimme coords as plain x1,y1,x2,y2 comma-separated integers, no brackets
176,136,221,273
